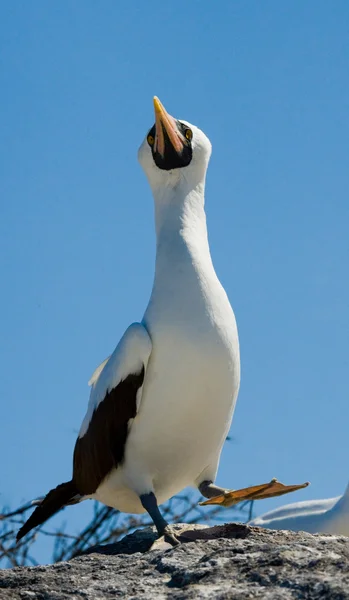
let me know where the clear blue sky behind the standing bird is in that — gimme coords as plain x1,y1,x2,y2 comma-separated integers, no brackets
0,0,349,559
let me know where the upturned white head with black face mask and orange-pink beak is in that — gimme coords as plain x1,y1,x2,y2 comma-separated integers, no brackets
138,96,211,189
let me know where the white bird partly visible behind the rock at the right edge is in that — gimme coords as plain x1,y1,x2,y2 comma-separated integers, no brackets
248,484,349,536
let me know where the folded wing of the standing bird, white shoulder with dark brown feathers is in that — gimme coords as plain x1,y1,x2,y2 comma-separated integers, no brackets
73,323,152,496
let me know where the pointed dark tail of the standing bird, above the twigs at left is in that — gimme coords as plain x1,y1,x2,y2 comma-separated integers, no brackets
16,481,78,542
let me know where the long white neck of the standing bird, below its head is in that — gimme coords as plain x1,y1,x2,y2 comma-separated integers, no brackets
147,178,216,319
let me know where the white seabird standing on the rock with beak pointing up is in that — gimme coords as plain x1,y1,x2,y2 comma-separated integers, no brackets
17,97,240,543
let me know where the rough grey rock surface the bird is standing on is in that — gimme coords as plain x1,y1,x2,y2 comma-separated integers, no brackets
0,524,349,600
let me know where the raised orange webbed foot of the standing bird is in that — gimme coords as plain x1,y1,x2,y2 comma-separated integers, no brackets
200,478,309,508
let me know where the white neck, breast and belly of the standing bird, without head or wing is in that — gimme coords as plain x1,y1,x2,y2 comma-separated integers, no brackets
95,190,239,513
